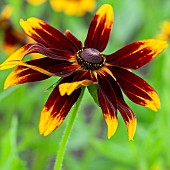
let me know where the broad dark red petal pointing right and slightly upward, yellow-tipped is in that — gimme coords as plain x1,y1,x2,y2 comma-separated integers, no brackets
106,39,168,69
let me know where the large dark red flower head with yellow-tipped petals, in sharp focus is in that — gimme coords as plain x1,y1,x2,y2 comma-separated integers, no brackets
0,4,168,140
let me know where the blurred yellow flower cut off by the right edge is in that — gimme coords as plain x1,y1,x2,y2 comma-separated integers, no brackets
158,21,170,41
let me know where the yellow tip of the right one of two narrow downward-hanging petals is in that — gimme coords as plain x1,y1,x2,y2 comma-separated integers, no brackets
126,117,137,140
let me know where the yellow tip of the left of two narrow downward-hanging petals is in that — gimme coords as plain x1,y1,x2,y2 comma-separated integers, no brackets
104,114,118,139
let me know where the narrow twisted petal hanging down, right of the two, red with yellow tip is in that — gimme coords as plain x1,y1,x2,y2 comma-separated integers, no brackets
108,75,137,140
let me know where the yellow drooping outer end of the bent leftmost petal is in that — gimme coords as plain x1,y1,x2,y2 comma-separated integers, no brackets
0,44,36,70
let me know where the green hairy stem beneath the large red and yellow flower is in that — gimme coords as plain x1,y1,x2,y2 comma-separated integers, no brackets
54,87,84,170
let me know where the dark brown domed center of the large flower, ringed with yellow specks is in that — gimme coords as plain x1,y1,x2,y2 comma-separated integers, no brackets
76,48,105,70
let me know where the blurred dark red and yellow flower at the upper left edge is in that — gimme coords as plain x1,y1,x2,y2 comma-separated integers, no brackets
0,6,26,55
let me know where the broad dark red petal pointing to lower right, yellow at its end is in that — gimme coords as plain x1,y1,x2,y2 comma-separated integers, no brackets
110,67,160,111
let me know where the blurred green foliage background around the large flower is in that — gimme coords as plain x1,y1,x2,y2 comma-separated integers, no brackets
0,0,170,170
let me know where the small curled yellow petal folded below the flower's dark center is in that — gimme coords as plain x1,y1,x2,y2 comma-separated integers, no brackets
59,80,93,96
